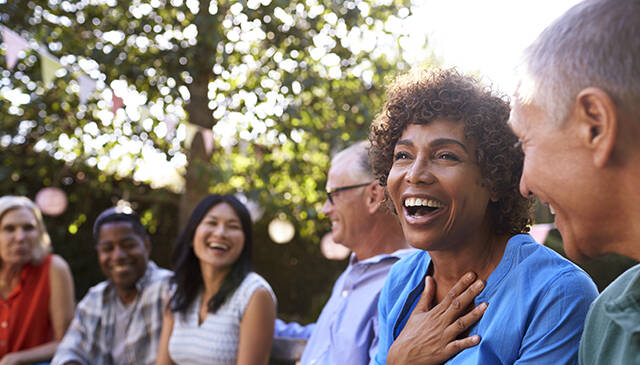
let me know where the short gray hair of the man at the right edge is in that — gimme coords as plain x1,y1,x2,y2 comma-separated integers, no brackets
518,0,640,124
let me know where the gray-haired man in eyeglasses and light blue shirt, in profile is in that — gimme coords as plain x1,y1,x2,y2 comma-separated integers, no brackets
275,141,413,365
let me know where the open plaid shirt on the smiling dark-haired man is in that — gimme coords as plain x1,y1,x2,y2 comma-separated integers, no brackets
51,261,171,365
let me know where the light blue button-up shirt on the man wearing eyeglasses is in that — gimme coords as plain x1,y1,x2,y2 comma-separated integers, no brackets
275,249,415,365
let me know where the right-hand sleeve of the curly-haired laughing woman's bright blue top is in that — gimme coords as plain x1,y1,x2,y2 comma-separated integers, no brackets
514,271,598,365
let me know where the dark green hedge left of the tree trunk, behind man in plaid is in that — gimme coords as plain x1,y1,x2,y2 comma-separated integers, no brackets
0,144,179,299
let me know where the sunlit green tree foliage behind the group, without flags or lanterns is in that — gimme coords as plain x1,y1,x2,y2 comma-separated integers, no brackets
0,0,420,319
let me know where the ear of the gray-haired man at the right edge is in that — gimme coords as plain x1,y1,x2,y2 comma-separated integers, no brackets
574,87,619,167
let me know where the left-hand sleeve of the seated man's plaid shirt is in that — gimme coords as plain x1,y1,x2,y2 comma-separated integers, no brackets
51,300,91,365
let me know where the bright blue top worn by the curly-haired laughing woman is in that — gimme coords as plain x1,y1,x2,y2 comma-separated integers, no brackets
376,234,598,365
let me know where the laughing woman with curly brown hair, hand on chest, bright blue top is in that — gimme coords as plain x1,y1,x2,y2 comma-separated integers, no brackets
369,70,597,364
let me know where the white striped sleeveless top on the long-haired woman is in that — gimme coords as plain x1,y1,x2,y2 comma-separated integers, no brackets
169,272,276,365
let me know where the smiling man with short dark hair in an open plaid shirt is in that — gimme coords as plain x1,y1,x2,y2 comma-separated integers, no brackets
52,207,171,365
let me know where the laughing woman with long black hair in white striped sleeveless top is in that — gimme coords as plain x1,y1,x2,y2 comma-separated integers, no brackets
156,195,276,365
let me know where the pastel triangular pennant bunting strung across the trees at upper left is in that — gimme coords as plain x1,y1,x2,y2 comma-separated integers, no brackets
0,24,214,154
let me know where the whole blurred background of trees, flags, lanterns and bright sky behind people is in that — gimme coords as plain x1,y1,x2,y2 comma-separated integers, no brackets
0,0,633,322
